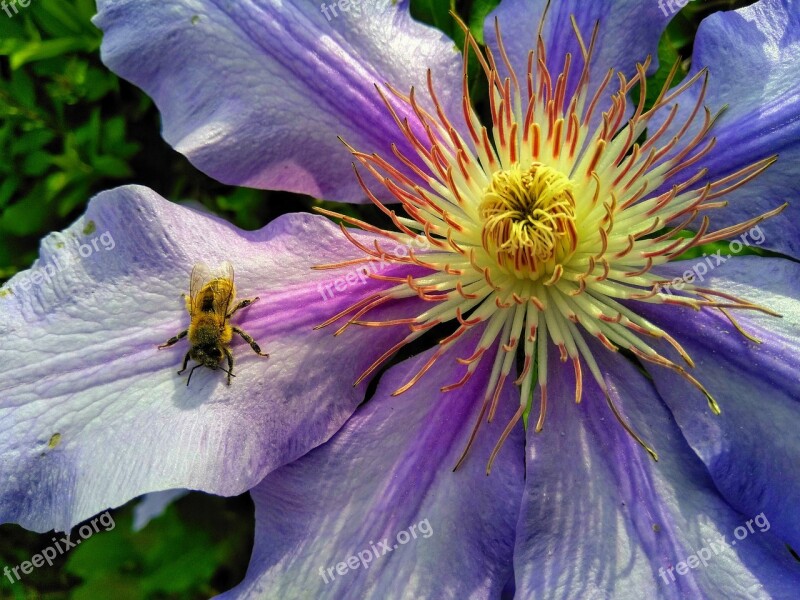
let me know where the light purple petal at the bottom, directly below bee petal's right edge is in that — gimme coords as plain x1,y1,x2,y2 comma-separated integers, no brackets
223,342,524,599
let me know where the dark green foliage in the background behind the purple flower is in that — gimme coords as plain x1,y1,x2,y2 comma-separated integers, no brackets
0,0,764,600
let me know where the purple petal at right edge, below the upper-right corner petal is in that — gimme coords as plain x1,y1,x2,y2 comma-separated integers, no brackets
640,257,800,549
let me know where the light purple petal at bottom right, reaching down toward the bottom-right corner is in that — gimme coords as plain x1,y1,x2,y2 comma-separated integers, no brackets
514,345,800,600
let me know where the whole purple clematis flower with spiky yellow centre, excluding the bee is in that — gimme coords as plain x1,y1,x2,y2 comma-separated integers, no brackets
0,0,800,598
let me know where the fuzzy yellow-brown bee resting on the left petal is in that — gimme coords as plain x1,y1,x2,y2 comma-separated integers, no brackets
158,261,269,386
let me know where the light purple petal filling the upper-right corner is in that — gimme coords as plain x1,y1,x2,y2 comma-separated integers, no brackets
653,0,800,257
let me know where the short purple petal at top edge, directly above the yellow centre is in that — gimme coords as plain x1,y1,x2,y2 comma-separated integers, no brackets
484,0,674,122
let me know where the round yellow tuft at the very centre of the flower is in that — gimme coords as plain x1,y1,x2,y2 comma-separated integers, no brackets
478,163,577,279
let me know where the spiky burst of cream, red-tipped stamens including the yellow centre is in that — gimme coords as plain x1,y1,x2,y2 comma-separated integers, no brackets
318,13,786,474
